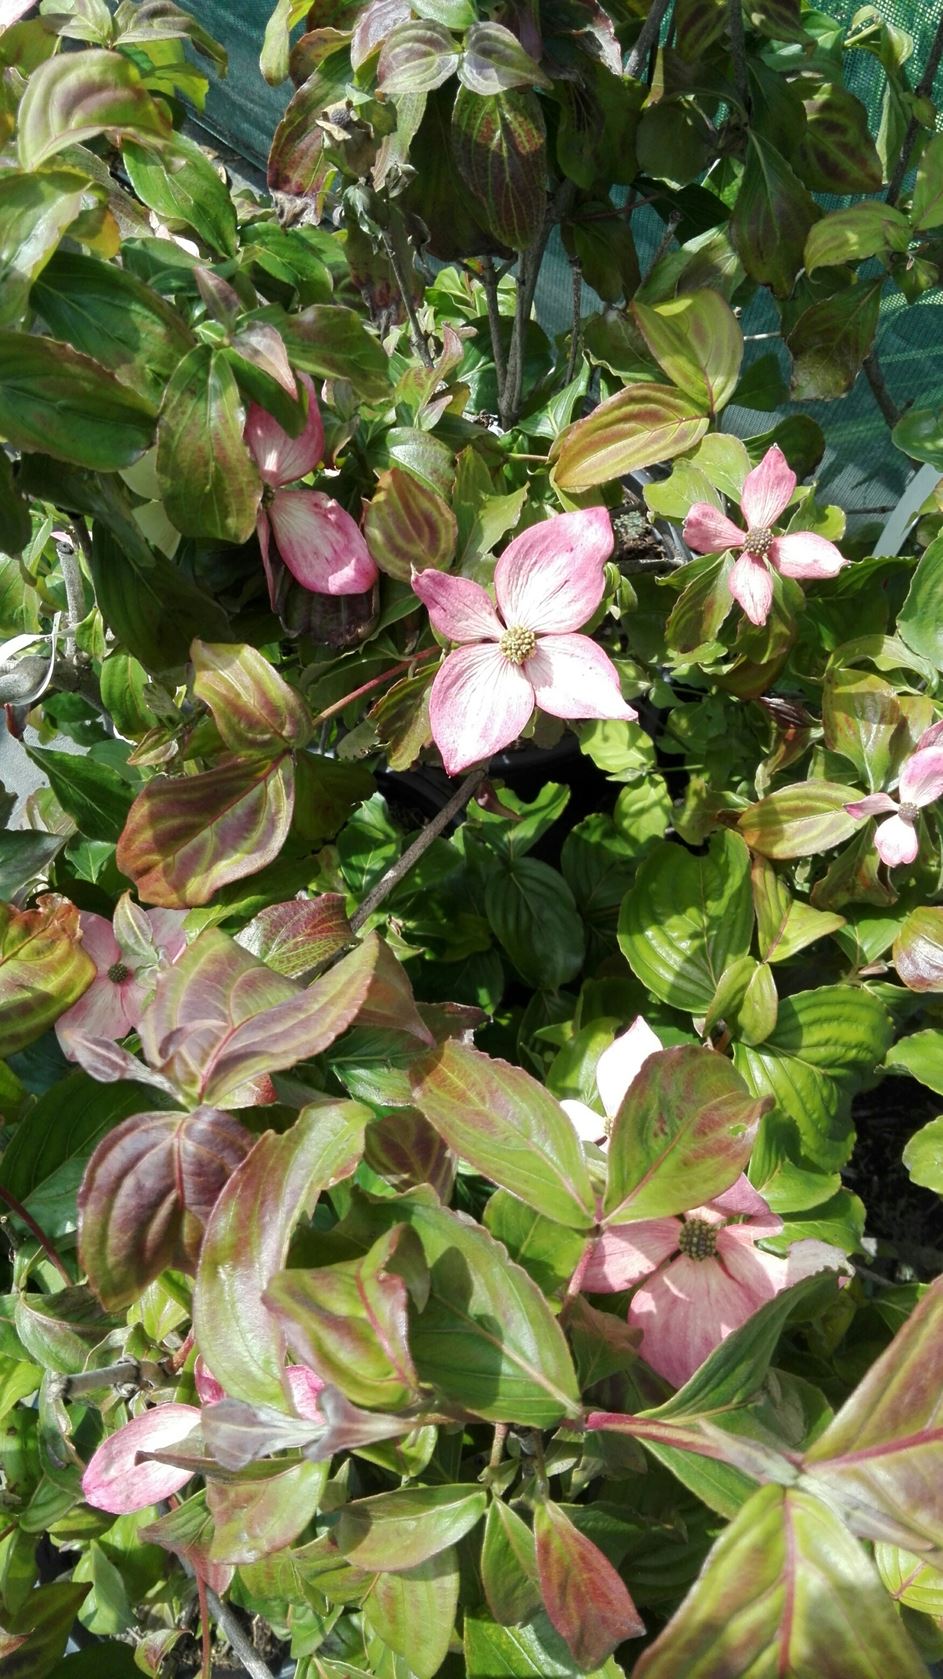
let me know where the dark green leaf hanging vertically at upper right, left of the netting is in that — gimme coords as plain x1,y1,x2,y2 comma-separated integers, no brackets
730,129,821,297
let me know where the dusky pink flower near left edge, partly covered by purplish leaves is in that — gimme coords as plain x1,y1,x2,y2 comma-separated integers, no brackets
55,893,186,1061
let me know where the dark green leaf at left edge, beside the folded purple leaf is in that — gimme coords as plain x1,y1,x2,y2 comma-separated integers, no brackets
0,1071,153,1241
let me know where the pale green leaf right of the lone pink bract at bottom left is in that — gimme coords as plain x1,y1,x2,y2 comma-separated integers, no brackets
206,1462,327,1567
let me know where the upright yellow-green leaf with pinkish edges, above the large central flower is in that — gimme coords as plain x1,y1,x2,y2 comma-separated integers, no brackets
633,292,743,415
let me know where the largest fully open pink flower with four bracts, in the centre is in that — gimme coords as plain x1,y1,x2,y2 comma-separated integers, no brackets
413,507,638,776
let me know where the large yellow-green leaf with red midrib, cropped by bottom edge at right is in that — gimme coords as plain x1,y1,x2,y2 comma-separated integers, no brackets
633,1486,926,1679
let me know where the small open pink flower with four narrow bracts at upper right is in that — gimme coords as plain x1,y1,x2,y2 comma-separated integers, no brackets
683,443,847,625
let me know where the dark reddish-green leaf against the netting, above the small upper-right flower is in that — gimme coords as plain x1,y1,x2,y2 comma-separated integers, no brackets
785,275,884,403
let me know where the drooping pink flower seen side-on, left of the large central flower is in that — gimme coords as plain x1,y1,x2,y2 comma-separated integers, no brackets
245,373,378,604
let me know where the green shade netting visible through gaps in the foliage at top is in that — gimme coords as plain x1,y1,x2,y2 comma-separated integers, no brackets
190,0,943,526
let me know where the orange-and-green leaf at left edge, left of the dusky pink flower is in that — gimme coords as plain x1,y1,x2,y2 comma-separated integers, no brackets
0,893,96,1056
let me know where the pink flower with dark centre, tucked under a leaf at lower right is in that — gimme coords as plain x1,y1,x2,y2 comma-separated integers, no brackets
581,1177,849,1387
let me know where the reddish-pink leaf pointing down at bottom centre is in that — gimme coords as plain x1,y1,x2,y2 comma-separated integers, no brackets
534,1499,644,1669
